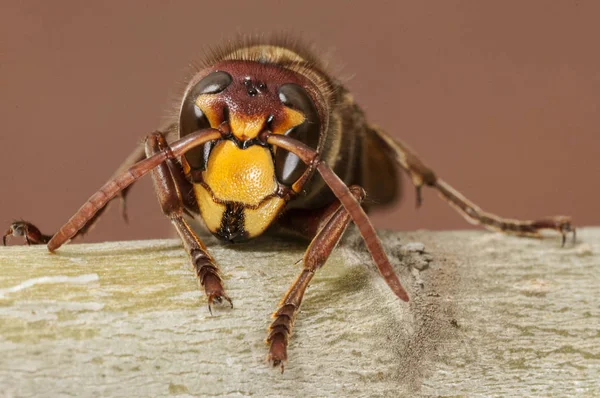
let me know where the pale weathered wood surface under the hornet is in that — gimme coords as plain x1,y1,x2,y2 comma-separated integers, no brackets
0,228,600,397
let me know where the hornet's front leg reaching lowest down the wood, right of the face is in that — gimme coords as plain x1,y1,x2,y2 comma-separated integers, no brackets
266,186,365,372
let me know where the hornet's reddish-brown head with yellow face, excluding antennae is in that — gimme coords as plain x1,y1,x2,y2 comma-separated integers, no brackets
179,49,328,241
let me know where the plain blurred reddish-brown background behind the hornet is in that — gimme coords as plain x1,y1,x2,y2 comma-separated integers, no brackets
0,0,600,241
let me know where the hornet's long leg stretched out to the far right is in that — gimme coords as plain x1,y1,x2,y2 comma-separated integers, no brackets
372,128,575,245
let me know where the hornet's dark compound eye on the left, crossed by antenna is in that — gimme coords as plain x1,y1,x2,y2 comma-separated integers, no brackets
179,71,233,170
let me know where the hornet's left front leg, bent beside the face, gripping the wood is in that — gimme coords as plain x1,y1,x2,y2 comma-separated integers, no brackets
146,133,233,313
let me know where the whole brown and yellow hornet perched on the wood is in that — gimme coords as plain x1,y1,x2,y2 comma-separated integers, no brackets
3,37,574,370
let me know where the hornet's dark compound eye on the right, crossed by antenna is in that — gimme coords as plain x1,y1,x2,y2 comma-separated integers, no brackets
275,83,321,186
